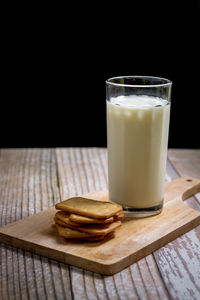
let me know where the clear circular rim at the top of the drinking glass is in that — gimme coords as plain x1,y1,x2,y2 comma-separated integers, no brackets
106,75,172,88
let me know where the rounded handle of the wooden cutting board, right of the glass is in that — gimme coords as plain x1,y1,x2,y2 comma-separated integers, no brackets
164,177,200,203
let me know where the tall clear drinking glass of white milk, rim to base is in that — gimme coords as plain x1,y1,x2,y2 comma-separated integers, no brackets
106,76,172,217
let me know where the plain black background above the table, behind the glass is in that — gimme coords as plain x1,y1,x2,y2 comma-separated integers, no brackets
0,1,200,148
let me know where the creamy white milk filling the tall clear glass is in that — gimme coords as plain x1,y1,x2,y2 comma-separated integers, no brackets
107,95,170,208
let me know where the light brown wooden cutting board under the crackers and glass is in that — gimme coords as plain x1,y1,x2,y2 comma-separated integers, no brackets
0,177,200,275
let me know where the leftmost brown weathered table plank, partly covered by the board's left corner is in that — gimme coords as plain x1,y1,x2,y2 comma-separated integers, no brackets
0,149,72,299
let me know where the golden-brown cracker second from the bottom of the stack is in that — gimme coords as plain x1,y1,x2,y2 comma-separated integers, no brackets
66,221,121,235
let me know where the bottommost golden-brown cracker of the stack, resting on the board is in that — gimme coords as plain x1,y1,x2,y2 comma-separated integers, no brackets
56,224,99,239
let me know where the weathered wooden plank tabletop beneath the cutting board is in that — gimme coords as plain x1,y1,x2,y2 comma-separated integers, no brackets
0,148,200,300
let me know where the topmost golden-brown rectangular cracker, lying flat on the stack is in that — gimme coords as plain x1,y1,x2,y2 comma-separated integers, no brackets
55,197,122,219
